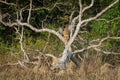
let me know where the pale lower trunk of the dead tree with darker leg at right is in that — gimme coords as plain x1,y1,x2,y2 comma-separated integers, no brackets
52,45,80,69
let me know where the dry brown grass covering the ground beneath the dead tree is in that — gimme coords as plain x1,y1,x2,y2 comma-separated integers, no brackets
0,55,120,80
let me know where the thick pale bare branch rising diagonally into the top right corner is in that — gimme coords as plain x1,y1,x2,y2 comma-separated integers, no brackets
81,0,119,24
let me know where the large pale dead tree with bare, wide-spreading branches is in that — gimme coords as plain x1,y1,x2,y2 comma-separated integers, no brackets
0,0,120,69
